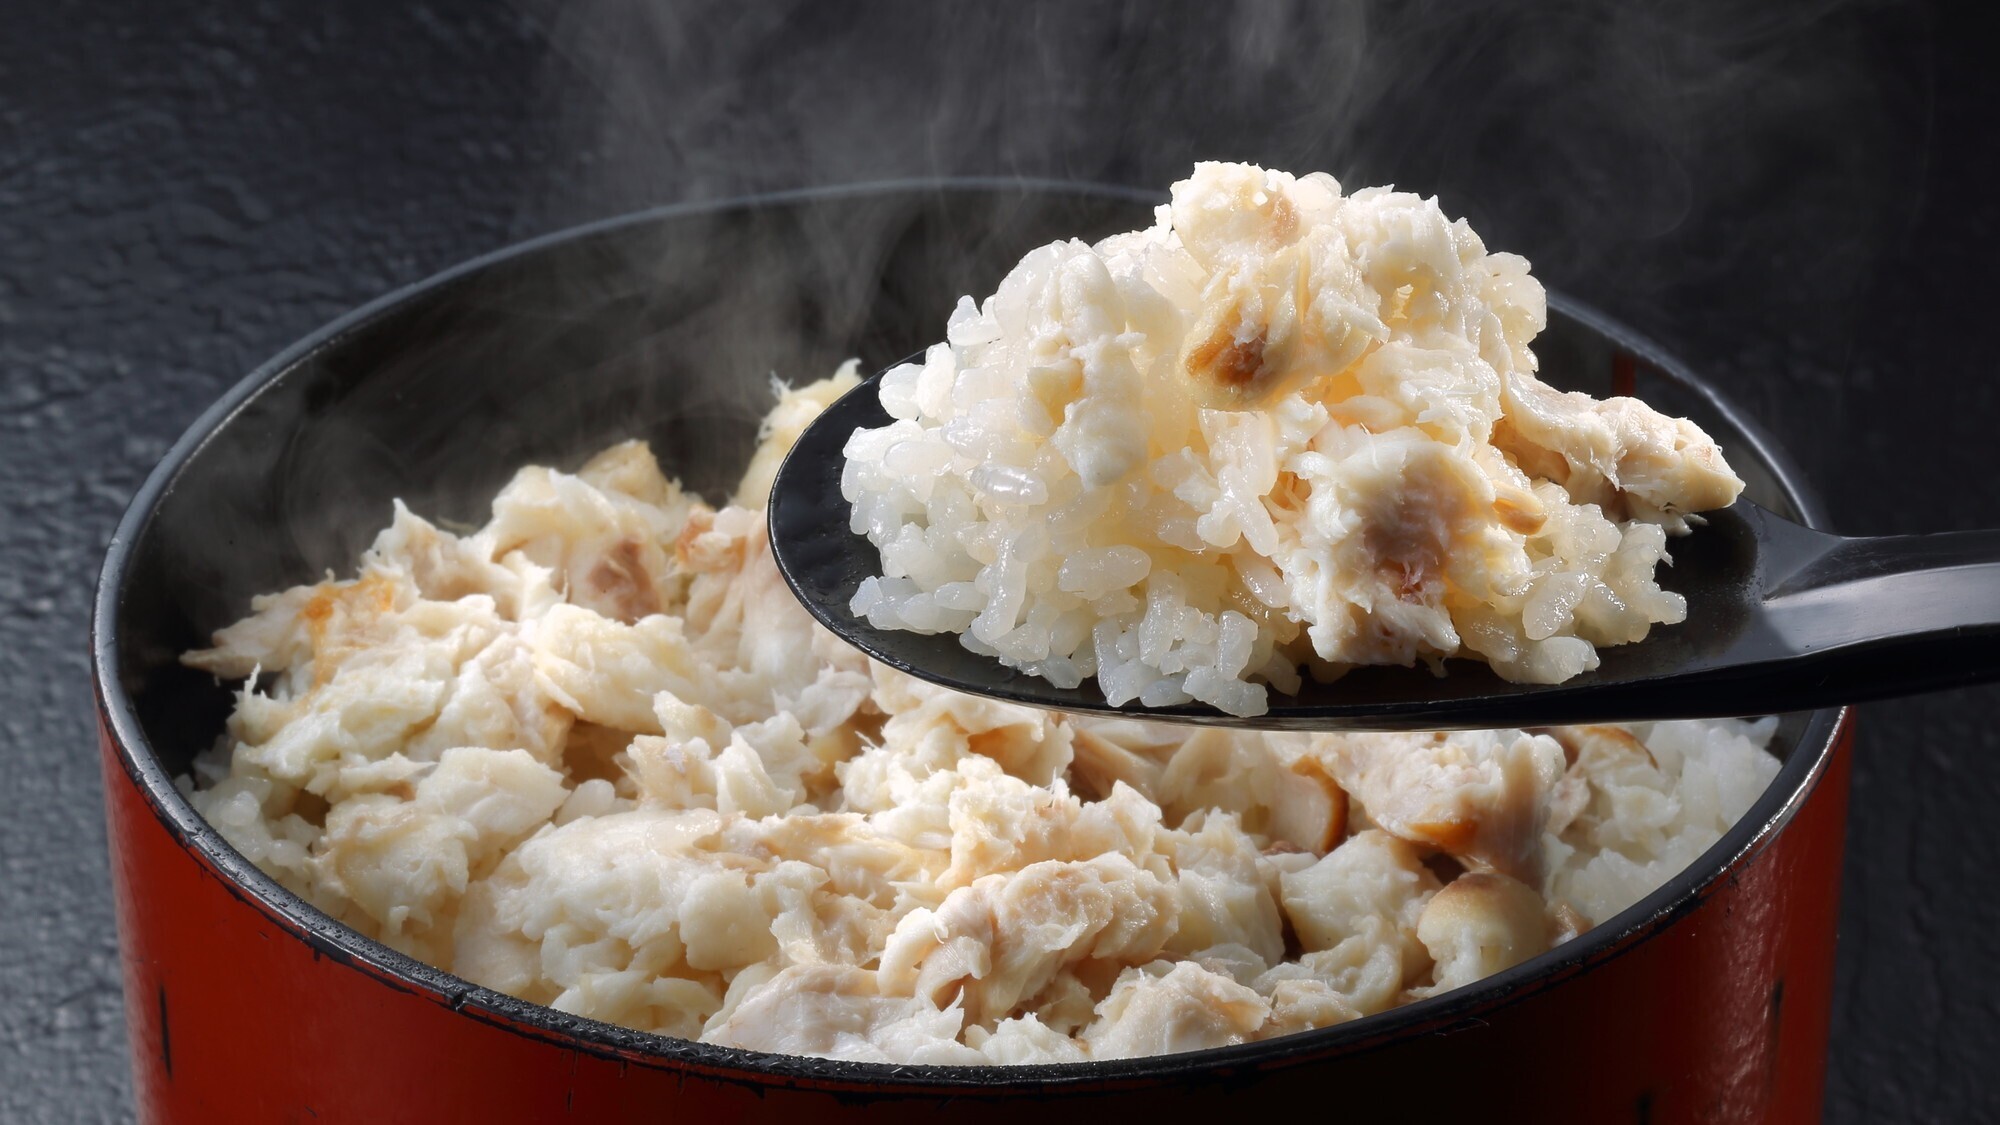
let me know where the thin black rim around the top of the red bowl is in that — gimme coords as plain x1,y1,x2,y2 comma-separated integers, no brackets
90,176,1852,1093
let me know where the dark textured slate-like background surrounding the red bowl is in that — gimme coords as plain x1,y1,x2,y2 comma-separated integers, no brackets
0,0,2000,1121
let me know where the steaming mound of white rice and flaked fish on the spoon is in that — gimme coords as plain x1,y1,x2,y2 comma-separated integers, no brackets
842,164,1742,715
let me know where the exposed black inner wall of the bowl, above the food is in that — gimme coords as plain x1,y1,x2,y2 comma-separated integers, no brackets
100,184,1830,1080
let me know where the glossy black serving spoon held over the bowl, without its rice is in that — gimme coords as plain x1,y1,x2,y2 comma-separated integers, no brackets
770,360,2000,731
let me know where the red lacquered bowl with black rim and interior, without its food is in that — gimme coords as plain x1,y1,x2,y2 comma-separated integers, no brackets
92,182,1852,1123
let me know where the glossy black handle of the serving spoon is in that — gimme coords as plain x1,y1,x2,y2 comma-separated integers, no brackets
1744,530,2000,705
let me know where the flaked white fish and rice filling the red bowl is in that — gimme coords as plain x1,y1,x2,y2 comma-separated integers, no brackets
184,372,1778,1063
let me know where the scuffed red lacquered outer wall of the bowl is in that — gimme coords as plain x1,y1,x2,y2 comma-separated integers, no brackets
90,700,1852,1125
